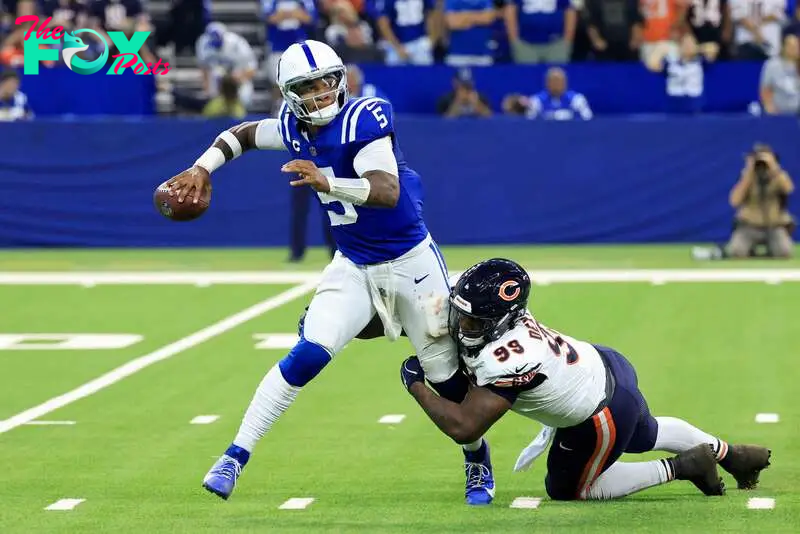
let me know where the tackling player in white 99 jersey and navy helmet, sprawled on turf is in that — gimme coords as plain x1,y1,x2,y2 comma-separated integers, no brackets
401,259,771,500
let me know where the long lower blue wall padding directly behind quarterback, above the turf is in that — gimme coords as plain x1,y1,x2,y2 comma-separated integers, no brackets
0,117,800,247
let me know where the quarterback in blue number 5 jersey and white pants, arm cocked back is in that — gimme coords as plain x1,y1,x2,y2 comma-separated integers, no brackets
168,41,494,505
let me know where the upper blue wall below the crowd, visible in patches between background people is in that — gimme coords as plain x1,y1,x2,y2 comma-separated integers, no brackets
15,62,761,116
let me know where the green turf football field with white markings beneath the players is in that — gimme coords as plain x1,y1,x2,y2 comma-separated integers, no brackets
0,247,800,533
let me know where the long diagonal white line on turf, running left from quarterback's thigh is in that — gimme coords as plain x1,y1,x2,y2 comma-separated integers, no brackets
0,282,316,434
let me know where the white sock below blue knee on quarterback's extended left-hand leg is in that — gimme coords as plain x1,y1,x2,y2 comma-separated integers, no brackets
233,364,301,452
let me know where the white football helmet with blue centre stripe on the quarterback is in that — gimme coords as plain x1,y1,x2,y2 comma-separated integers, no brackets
277,41,348,126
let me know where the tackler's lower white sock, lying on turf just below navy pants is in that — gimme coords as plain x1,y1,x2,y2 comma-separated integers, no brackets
581,460,675,500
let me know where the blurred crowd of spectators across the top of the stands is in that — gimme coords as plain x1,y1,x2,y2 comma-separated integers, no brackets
0,0,800,120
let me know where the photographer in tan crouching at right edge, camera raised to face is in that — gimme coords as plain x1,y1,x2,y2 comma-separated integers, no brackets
727,144,794,258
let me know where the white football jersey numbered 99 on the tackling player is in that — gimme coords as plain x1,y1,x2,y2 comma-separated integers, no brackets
464,313,606,428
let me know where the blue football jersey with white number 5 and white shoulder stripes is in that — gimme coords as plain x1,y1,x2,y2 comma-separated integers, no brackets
278,97,428,265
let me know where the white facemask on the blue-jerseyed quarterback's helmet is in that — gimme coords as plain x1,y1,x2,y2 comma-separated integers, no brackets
281,65,347,126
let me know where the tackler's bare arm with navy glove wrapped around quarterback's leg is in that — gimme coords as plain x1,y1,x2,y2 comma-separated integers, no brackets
400,357,511,444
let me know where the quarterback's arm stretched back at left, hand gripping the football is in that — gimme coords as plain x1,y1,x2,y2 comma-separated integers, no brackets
167,119,285,202
